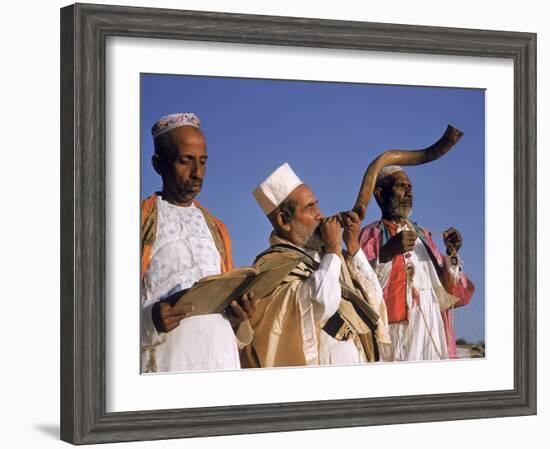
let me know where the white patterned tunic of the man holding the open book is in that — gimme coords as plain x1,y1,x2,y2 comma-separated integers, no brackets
141,197,254,372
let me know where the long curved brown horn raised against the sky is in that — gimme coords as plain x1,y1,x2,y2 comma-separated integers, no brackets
353,125,464,220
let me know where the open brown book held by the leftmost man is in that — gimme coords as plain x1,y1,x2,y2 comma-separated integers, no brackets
178,254,298,316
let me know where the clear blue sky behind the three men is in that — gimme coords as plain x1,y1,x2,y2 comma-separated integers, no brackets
140,74,485,341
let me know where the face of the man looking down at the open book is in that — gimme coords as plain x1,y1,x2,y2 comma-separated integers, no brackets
156,126,208,206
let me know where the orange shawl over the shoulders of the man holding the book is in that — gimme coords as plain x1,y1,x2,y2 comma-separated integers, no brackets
141,193,233,279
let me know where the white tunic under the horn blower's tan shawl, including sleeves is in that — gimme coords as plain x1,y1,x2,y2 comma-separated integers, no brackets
298,251,382,365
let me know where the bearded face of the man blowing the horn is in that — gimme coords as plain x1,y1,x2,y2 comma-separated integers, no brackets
288,184,324,249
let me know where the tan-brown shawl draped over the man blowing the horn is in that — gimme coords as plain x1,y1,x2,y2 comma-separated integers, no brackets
246,237,389,368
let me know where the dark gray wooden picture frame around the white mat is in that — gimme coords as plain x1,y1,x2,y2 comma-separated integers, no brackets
61,4,536,444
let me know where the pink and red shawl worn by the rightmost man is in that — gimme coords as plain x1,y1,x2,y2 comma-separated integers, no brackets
359,221,475,358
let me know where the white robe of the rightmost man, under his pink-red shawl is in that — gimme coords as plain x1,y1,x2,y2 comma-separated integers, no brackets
376,224,448,361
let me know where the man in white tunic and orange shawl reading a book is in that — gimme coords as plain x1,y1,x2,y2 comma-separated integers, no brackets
140,113,254,372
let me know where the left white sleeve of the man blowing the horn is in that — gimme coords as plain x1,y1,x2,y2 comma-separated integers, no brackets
298,254,342,322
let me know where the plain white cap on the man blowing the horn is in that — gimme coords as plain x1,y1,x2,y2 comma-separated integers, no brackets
252,162,303,215
